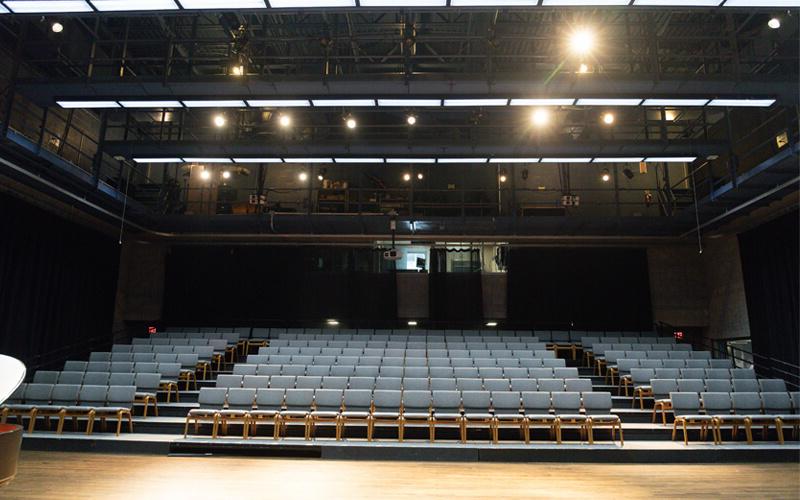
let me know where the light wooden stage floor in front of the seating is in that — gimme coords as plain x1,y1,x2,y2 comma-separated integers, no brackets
0,451,800,500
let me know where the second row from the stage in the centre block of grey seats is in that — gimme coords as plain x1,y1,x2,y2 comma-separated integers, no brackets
216,375,592,392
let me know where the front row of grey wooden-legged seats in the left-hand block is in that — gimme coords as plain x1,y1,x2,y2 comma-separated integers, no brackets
0,384,136,436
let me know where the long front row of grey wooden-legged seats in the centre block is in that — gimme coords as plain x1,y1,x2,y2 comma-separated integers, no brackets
184,387,623,444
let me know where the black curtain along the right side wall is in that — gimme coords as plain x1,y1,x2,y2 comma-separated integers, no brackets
739,211,800,365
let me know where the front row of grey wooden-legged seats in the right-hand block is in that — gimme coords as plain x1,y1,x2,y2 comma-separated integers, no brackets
669,391,800,444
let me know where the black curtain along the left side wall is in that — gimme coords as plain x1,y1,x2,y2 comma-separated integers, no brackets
0,194,119,365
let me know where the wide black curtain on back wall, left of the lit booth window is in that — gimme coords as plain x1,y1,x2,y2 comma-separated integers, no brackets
164,246,397,326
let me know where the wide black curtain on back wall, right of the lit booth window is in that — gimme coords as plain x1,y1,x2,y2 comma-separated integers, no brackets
507,248,653,331
